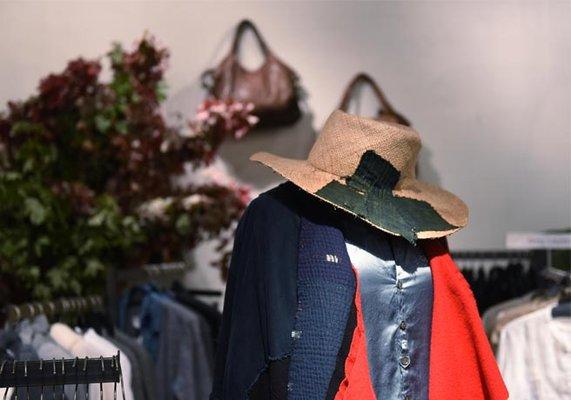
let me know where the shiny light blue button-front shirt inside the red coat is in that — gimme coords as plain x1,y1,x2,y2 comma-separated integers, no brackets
347,233,433,400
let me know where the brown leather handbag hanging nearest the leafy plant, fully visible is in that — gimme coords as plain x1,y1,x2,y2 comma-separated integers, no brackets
202,20,301,127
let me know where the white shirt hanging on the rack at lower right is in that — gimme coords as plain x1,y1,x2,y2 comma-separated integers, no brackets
498,305,571,400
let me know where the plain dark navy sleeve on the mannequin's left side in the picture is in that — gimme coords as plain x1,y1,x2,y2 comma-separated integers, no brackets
210,185,300,400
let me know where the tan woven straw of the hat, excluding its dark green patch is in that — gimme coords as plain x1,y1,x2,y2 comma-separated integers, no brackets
250,110,468,239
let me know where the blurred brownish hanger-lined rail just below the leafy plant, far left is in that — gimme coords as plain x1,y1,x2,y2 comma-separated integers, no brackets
0,295,104,326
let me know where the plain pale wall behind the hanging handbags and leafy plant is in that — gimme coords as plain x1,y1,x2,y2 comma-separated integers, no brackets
0,2,571,256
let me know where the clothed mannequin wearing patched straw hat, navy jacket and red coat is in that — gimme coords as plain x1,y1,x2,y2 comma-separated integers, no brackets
211,111,508,400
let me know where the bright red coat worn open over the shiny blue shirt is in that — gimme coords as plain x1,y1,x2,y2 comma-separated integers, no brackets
335,240,508,400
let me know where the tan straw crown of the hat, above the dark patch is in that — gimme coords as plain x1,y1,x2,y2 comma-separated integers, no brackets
308,110,421,178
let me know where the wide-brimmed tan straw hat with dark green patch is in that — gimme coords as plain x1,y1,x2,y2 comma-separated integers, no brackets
250,110,468,243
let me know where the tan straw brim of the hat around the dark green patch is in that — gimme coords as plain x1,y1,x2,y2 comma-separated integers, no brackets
250,152,468,239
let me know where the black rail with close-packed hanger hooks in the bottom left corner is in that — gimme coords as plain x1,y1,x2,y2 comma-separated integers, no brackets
0,353,120,390
